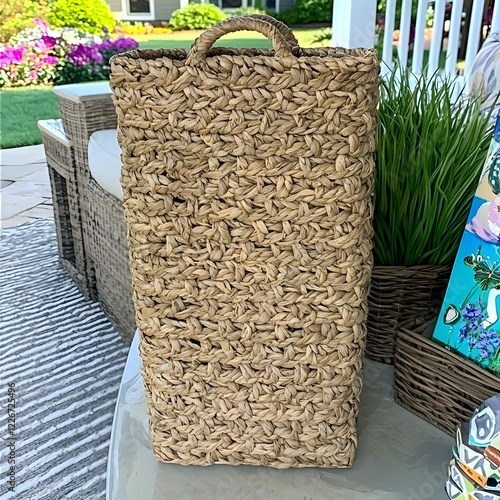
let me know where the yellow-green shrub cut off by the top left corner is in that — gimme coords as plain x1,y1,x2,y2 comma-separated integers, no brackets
0,0,48,42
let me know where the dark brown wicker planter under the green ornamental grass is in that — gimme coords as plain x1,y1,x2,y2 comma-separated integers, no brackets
366,265,451,364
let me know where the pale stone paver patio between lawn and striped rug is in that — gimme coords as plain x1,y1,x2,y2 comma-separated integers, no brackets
0,144,54,228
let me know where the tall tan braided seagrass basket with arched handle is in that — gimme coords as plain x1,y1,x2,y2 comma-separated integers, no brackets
111,16,379,468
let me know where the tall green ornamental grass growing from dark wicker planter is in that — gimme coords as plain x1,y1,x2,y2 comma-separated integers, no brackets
374,69,492,266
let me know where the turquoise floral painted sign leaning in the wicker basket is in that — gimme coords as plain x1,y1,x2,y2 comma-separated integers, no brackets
432,119,500,376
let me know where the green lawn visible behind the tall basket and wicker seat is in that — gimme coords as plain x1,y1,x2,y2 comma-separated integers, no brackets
0,29,322,148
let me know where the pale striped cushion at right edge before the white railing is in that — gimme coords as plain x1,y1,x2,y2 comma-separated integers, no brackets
469,33,500,116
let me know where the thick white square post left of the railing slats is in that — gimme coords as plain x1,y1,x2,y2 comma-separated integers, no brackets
331,0,377,49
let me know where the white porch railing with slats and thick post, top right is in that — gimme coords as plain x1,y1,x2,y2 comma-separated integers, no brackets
332,0,500,86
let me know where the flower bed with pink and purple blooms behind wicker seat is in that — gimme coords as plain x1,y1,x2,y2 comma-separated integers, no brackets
0,19,138,87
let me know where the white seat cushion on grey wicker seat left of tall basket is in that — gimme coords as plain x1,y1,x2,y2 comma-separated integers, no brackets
89,129,123,200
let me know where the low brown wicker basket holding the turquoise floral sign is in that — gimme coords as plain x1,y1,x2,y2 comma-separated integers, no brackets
395,321,500,435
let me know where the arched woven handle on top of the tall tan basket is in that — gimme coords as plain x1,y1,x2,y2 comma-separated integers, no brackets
186,16,295,66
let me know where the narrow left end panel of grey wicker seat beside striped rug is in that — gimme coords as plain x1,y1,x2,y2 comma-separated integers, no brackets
41,125,92,298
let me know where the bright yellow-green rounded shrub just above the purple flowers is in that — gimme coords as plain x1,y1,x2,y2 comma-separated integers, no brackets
48,0,115,35
